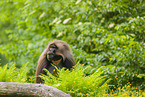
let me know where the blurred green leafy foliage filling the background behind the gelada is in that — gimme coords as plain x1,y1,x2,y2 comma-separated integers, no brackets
0,0,145,95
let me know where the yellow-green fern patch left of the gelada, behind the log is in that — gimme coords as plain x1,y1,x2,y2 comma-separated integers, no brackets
0,63,28,82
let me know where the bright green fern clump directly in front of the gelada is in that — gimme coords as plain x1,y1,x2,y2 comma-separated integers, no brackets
41,64,109,97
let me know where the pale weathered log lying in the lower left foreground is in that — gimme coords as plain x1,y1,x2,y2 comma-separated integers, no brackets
0,82,71,97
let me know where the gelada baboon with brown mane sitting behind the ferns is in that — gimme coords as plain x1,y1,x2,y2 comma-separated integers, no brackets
35,40,75,83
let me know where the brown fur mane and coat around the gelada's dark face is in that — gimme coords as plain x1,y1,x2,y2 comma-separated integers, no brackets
35,40,75,83
